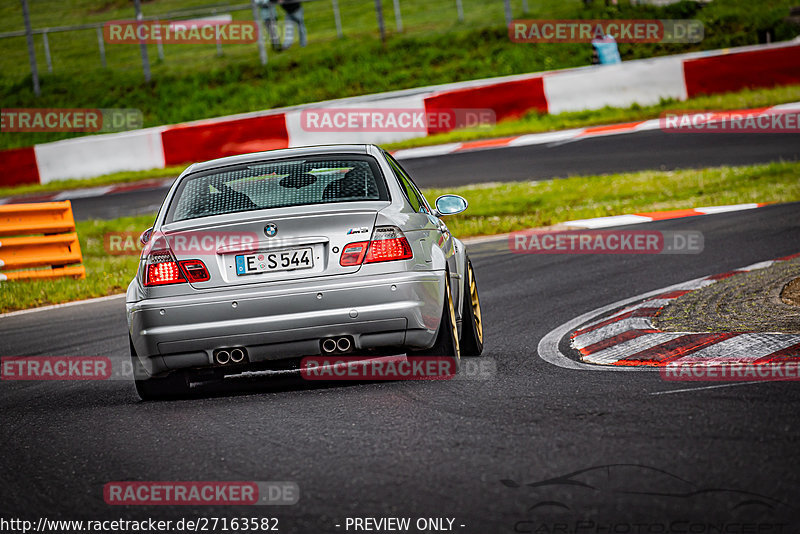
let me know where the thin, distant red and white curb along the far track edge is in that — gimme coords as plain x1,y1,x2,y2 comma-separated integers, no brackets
392,102,800,159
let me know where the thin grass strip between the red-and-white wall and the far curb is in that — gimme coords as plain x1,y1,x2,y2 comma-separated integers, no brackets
0,85,800,197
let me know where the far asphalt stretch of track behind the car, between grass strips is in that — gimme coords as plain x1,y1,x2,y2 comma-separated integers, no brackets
64,131,800,220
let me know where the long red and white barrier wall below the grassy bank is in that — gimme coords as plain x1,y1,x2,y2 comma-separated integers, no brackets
0,41,800,186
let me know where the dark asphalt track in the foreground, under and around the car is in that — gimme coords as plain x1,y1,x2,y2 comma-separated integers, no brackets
0,203,800,534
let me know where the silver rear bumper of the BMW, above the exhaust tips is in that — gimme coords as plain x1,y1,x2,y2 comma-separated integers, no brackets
127,271,445,374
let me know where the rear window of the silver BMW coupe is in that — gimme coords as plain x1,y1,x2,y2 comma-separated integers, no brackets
167,155,389,222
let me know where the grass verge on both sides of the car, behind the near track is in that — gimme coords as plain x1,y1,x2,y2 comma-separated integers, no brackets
0,163,800,312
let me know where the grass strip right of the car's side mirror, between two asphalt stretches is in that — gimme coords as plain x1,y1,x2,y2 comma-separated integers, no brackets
425,162,800,237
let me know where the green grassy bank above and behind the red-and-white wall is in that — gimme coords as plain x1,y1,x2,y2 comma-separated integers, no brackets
0,0,798,148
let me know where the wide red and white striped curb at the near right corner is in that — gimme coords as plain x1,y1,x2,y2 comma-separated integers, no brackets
538,253,800,371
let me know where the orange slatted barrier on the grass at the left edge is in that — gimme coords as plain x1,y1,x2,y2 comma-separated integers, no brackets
0,200,86,281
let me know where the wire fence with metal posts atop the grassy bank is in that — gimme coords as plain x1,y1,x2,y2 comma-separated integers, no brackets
0,0,544,86
